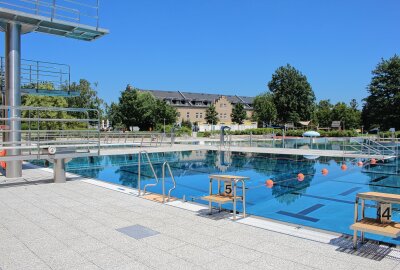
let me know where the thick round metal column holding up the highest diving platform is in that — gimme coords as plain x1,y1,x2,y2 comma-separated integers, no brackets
5,22,22,178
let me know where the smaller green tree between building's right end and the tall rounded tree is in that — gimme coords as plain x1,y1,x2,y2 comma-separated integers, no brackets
253,93,277,124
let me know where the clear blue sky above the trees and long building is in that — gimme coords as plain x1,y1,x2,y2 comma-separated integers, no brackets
0,0,400,105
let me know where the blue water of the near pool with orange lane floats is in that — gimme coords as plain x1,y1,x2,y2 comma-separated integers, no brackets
44,150,400,244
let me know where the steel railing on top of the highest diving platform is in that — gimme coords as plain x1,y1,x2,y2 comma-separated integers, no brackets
0,0,99,29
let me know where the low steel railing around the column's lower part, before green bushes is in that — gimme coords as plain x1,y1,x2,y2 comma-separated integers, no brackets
0,105,100,160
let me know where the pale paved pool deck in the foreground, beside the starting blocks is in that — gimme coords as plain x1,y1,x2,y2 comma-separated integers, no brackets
0,166,400,270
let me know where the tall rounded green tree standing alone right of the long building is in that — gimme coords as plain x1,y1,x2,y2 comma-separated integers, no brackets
268,64,315,123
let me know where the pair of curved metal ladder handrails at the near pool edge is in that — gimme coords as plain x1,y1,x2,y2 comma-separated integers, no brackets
138,150,176,203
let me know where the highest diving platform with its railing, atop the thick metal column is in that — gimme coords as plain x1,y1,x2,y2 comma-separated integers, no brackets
0,0,109,41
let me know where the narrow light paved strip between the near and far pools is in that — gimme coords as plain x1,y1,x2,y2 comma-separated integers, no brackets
100,144,393,159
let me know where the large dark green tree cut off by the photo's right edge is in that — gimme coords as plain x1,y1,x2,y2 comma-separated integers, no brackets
362,55,400,130
